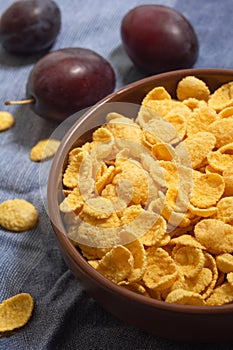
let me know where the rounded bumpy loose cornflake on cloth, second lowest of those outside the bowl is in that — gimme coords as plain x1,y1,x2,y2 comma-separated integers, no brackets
0,199,38,232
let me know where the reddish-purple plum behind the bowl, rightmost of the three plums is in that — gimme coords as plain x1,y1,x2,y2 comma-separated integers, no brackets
120,5,199,75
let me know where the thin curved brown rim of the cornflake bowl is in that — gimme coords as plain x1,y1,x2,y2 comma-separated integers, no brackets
47,68,233,314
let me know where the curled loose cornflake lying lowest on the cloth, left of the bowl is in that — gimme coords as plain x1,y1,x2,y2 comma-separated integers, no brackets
0,293,34,332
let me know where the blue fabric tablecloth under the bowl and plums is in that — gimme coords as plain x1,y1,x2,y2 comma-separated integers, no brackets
0,0,233,350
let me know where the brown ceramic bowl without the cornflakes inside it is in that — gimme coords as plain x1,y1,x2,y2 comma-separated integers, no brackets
48,69,233,342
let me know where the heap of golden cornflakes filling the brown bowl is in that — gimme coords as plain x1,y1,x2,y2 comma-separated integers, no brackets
60,76,233,306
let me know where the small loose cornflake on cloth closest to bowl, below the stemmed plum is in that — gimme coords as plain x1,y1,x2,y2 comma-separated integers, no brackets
30,139,60,162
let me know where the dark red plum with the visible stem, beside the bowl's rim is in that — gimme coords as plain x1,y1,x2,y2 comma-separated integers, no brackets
26,48,115,121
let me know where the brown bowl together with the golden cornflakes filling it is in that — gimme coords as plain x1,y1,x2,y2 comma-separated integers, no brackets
48,68,233,342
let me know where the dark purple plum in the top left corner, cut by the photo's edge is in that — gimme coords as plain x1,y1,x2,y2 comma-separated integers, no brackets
0,0,61,54
